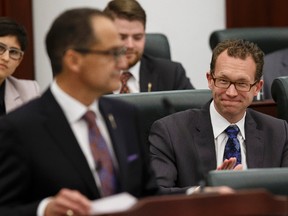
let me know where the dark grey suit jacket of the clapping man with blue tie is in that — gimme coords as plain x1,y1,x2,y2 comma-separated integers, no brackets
149,104,288,192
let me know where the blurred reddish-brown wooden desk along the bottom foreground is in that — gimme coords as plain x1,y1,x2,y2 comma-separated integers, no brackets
98,190,288,216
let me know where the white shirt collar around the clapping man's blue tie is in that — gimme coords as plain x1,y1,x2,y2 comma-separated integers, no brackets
210,101,246,140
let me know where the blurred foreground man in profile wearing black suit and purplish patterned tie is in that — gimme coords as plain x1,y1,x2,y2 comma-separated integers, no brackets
0,8,158,216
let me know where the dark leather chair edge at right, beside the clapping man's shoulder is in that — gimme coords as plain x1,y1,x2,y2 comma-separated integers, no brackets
271,76,288,122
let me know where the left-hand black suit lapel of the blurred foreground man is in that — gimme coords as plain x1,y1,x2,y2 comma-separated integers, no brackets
42,90,99,197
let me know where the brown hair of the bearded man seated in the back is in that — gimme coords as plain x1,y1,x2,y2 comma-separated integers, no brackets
104,0,146,28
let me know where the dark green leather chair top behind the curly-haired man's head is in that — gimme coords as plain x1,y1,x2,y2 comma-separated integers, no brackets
209,27,288,54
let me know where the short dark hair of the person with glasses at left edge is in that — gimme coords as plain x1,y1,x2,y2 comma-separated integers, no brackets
0,17,28,51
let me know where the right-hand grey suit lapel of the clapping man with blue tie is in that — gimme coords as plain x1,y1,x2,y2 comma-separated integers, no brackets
245,109,264,168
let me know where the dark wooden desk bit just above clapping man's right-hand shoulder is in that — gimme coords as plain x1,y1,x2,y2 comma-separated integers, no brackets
249,99,277,118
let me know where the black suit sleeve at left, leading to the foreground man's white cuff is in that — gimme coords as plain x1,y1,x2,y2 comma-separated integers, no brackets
0,119,39,216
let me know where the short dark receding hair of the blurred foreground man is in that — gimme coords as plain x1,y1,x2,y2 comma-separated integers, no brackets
46,8,111,76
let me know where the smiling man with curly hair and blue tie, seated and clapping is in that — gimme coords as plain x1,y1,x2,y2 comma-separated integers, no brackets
149,40,288,194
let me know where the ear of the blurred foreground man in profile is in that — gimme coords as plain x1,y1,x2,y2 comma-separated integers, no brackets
63,49,82,73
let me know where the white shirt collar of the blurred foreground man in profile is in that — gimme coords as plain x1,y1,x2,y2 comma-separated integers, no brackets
51,80,100,123
